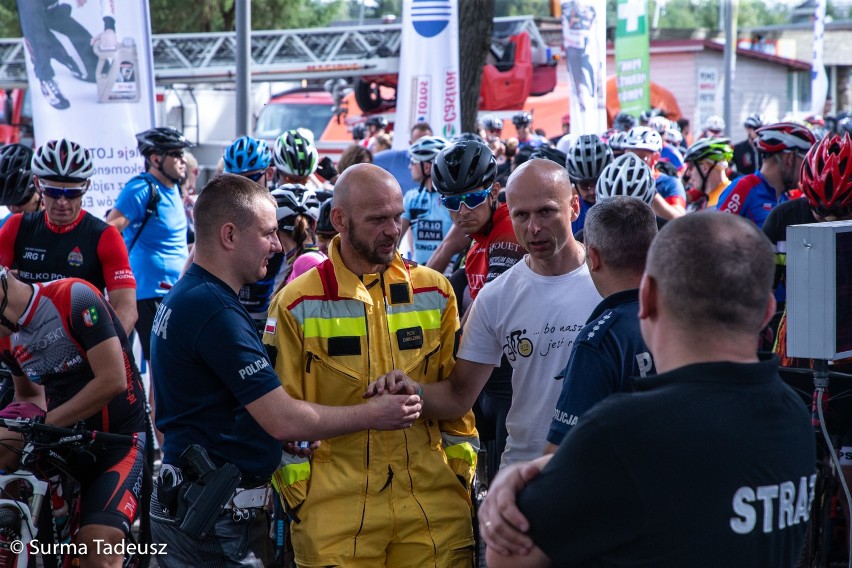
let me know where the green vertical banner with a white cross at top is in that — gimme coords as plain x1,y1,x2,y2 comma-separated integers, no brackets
615,0,651,116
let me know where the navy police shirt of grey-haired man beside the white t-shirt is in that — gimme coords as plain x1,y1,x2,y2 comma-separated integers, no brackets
547,289,656,445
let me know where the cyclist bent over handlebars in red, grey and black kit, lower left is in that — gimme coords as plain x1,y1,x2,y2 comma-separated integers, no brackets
0,266,146,568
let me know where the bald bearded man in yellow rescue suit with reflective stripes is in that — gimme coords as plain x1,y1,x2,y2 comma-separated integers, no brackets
263,164,479,567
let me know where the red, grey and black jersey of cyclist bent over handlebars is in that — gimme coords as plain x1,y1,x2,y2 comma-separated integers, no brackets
0,278,145,434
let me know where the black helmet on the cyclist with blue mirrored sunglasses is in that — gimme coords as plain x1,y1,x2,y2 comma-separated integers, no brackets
432,140,497,195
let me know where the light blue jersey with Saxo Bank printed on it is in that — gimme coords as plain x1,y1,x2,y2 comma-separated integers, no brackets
402,187,453,264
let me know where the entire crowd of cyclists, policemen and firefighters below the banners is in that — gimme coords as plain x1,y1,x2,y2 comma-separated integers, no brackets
0,102,852,568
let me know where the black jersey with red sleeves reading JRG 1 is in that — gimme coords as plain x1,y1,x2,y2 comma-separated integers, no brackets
0,211,136,290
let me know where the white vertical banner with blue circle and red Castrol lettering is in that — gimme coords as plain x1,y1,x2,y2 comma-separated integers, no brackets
393,0,461,150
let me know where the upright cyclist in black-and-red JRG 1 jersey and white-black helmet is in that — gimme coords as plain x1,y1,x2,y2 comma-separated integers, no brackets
0,139,136,333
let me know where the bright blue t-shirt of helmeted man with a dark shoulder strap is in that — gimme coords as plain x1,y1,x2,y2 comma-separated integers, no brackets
115,174,189,300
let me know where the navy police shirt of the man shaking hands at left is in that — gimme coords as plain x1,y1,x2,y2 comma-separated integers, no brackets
151,264,281,479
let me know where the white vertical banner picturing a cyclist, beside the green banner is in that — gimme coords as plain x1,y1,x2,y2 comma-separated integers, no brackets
562,0,606,138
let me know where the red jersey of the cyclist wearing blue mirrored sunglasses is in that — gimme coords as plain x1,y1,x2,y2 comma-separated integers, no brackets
465,203,527,300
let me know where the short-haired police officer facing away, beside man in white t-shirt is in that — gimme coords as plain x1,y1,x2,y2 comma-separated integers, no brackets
544,197,657,453
